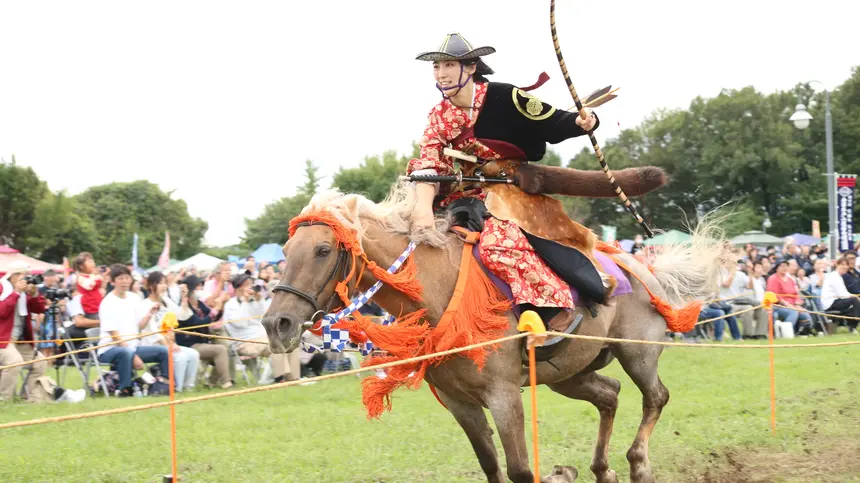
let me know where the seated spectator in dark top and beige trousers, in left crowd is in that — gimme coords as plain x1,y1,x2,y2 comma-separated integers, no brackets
176,275,233,389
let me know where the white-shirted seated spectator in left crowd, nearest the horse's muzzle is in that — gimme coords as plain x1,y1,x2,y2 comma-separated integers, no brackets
224,273,301,382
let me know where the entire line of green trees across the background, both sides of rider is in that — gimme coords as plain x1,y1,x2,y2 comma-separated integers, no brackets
0,67,860,265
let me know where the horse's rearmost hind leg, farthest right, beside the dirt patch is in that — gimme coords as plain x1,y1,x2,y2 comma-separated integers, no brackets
613,344,669,483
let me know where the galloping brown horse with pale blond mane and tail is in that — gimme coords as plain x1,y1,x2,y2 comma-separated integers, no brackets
263,187,722,483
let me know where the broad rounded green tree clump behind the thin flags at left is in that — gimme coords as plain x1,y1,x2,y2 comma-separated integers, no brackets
77,181,209,267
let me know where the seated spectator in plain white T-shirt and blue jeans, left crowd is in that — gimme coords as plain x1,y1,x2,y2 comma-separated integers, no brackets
98,264,168,397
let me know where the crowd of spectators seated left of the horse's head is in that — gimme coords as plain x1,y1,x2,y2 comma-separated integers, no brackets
0,253,326,400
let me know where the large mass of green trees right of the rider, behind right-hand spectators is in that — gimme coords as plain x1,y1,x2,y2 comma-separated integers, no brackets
568,68,860,238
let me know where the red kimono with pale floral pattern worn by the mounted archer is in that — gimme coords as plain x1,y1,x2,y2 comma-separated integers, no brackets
407,82,574,309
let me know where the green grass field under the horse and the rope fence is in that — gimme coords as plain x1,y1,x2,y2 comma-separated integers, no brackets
0,335,860,483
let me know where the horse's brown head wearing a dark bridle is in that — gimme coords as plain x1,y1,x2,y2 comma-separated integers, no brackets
263,223,352,353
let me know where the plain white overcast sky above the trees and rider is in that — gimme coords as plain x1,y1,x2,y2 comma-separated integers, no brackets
0,0,860,245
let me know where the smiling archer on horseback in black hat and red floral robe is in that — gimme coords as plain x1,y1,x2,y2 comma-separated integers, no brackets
407,33,599,326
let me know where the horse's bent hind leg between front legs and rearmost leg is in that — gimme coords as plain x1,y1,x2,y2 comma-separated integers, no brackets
549,372,621,483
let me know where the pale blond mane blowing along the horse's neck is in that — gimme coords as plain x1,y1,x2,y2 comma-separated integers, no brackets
302,182,449,247
